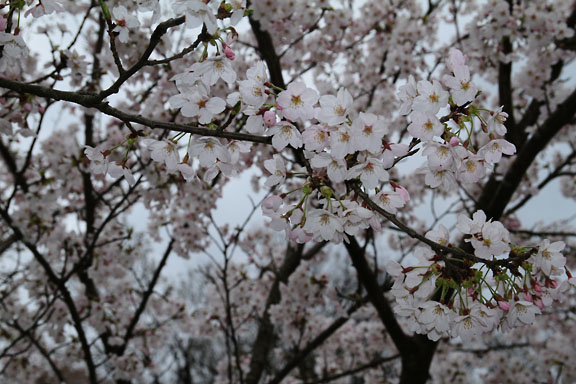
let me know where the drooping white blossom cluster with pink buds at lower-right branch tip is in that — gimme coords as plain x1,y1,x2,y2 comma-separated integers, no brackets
386,211,576,341
